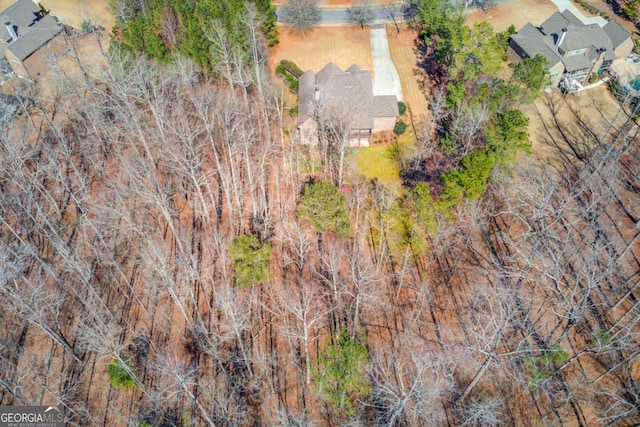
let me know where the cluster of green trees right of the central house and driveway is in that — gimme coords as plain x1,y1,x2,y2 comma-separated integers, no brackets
408,0,536,207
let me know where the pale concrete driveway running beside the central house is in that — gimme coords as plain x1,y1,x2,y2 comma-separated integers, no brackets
370,27,402,101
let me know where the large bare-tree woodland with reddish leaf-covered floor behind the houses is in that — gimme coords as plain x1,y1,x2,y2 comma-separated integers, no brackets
0,0,640,426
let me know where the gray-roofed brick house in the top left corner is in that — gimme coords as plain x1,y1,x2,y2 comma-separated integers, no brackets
0,0,67,81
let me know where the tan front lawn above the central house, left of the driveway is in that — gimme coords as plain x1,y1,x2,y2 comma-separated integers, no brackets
270,27,373,75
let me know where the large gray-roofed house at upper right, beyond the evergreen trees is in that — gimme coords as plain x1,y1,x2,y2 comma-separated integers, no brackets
509,10,633,90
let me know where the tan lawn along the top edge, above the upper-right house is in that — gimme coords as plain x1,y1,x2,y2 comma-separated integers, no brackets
467,0,558,31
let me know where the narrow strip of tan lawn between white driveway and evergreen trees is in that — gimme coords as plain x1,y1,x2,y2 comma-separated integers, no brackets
387,27,429,118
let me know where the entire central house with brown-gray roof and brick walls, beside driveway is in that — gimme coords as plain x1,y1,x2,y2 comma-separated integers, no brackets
298,62,399,146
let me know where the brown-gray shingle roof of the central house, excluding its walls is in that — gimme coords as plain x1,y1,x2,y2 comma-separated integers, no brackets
298,62,398,129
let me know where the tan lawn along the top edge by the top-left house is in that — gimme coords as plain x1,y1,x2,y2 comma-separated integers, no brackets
0,0,115,32
